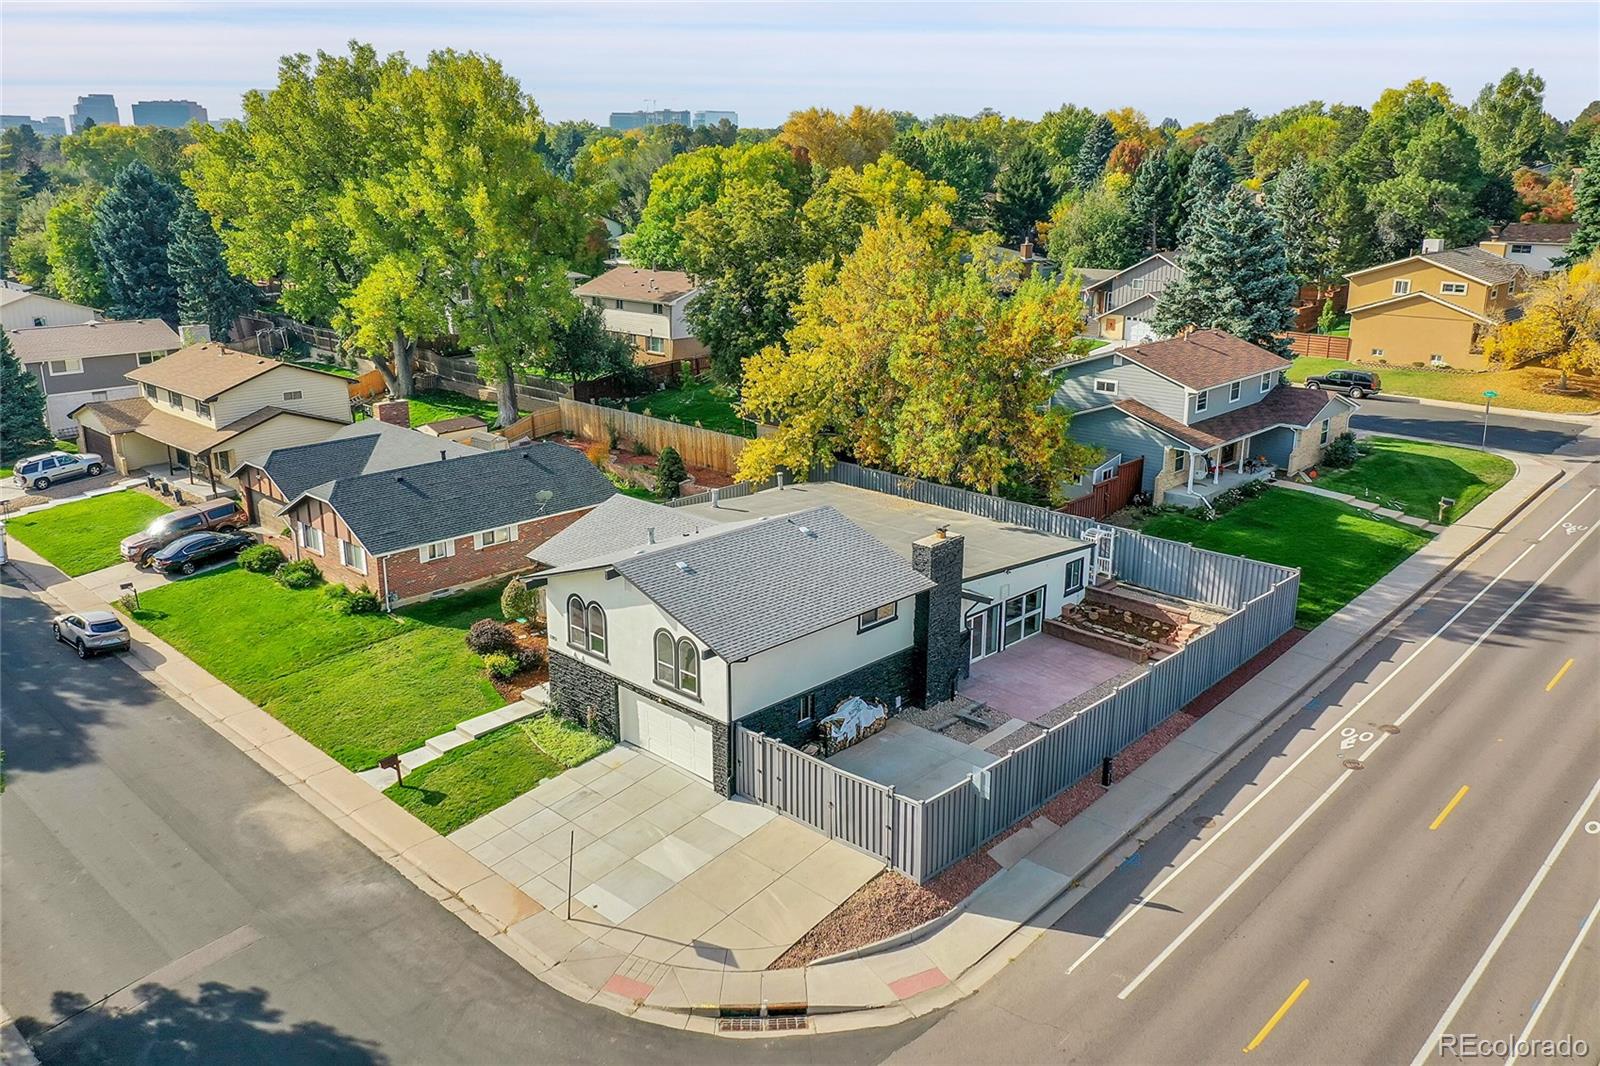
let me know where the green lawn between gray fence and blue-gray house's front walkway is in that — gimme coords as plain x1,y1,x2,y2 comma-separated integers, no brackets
1141,488,1429,629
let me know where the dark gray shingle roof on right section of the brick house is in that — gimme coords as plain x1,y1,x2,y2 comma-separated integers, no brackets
305,439,616,555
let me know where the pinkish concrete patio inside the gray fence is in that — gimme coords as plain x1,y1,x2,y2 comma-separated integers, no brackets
962,634,1139,722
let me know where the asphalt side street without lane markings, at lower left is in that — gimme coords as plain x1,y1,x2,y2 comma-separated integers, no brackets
0,578,928,1063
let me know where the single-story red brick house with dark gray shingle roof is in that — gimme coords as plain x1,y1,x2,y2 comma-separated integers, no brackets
235,419,616,608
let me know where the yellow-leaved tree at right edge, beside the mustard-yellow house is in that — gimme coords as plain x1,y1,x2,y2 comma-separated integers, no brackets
1483,253,1600,389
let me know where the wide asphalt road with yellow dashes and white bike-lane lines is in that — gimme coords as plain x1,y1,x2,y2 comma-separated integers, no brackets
893,467,1600,1064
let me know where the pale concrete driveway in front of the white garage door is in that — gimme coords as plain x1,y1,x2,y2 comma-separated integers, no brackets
450,746,883,970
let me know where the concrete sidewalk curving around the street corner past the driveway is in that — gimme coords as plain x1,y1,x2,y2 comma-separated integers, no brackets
0,444,1560,1037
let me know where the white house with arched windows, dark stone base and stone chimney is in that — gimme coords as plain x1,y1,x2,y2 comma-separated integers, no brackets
531,483,1093,794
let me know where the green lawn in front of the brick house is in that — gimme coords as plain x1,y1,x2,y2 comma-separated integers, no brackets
134,567,504,770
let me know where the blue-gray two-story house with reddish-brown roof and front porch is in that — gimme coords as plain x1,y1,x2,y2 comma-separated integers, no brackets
1053,330,1360,507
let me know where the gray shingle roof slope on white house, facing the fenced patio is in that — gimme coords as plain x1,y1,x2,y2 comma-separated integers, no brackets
613,507,933,661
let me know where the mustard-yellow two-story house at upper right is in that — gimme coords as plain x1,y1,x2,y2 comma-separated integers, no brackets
1346,242,1528,370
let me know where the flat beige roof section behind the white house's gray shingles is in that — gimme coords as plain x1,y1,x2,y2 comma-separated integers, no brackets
680,482,1088,581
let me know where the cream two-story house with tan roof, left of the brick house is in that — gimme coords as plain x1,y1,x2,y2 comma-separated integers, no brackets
72,341,350,491
